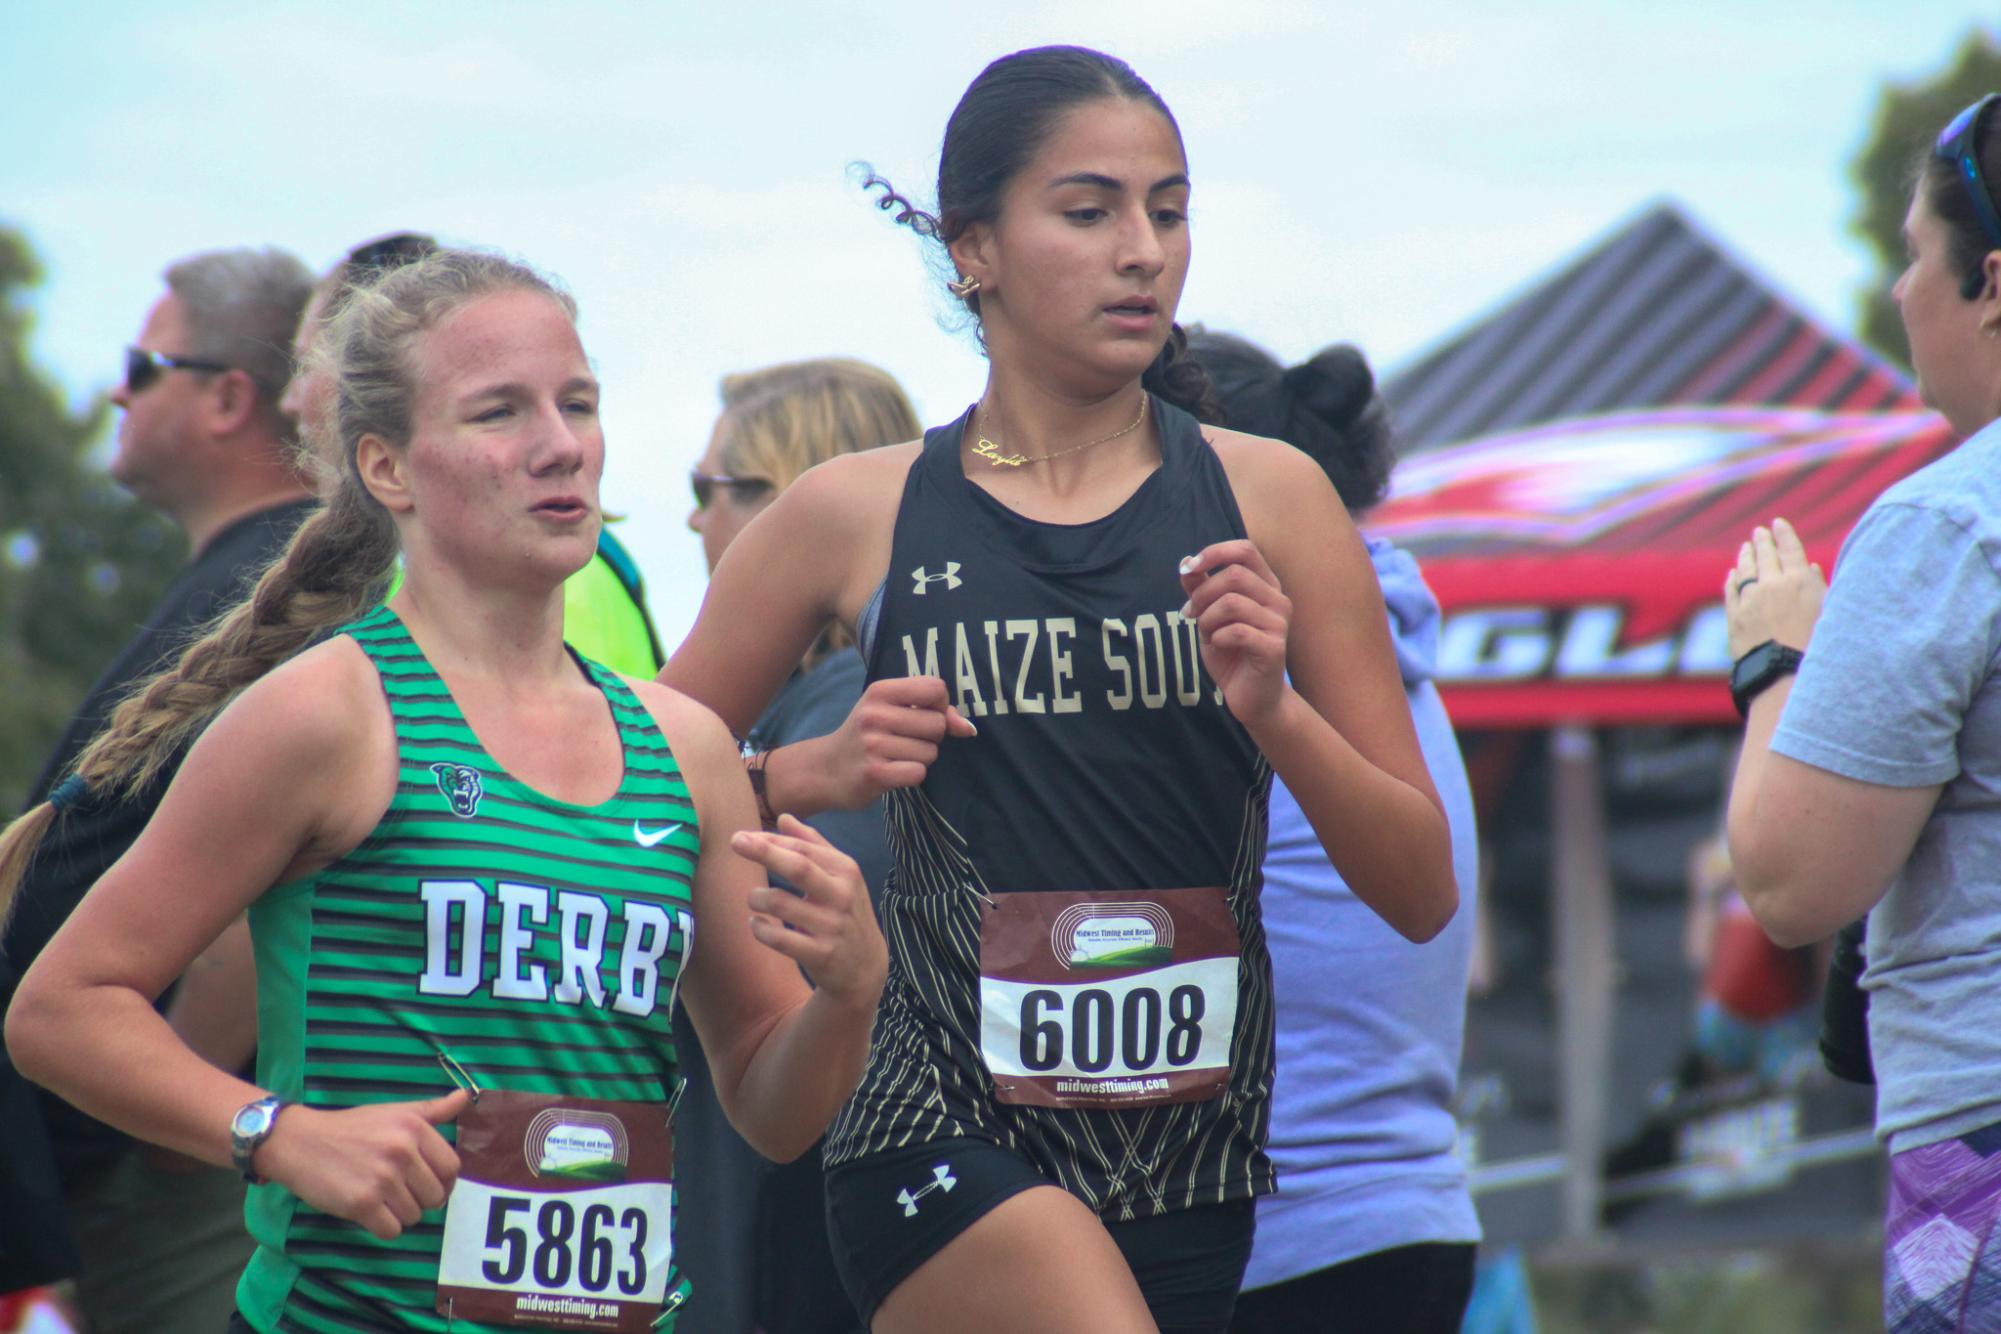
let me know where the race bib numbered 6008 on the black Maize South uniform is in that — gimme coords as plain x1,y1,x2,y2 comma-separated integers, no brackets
980,886,1239,1108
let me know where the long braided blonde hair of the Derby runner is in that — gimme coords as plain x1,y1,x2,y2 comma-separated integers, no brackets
0,250,576,918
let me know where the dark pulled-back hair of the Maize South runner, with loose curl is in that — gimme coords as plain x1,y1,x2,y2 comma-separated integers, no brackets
862,46,1219,422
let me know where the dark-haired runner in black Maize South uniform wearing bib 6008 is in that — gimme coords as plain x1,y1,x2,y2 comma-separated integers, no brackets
662,48,1457,1334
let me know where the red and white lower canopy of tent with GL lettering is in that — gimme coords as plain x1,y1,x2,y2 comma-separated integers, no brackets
1369,408,1953,728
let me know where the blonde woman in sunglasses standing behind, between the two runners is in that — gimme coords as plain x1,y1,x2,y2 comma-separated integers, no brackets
676,358,920,1334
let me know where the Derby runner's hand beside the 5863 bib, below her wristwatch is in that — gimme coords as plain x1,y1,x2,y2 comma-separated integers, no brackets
252,1088,468,1242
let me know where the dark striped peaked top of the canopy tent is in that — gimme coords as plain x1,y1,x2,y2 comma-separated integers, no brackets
1383,202,1919,452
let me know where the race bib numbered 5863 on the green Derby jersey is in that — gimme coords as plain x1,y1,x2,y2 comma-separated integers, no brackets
436,1088,674,1334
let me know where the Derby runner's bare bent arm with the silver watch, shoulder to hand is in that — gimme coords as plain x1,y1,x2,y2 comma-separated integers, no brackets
6,640,464,1238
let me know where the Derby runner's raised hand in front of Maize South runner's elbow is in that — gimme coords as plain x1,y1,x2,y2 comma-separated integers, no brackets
730,816,888,1012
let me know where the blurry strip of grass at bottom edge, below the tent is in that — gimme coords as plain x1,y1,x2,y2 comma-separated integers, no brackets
1529,1248,1883,1334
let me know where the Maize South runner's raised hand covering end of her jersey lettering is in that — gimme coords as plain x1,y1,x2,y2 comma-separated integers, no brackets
1176,538,1293,726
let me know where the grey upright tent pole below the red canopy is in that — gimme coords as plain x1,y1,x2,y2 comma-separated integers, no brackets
1549,722,1613,1240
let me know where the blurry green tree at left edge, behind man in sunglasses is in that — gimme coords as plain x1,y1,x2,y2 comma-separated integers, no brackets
0,226,186,820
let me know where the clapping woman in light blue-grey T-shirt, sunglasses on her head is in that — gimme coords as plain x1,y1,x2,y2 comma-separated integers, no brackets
1725,94,2001,1334
